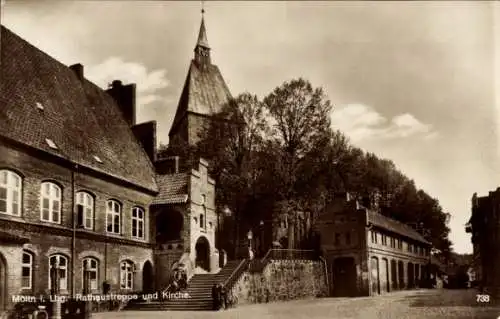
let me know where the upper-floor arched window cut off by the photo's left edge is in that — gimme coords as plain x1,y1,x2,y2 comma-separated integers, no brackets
0,170,22,216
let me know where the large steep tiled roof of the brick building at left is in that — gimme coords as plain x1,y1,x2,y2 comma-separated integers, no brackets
0,26,157,191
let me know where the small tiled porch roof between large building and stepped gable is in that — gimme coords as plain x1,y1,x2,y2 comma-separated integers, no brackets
153,173,188,205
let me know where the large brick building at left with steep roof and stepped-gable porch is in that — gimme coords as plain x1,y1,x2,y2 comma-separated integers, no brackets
0,14,225,314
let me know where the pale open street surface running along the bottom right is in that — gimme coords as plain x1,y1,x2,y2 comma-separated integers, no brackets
93,289,500,319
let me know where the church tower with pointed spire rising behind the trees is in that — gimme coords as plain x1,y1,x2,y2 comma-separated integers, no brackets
169,10,231,145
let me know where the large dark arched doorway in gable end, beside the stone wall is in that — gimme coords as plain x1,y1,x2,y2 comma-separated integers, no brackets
333,257,357,297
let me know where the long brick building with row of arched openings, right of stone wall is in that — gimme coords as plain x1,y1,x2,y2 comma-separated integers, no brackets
315,194,431,296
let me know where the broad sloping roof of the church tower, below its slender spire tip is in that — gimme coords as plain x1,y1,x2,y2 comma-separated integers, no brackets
170,60,231,133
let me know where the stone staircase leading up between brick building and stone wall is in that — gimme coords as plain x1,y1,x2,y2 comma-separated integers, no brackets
125,260,246,311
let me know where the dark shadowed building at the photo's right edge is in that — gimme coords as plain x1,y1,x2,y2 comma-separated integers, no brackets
465,188,500,293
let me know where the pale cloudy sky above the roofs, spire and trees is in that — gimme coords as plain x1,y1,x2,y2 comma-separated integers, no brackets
1,0,500,253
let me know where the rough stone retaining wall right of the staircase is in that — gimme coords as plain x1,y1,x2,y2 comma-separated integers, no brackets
229,260,328,305
